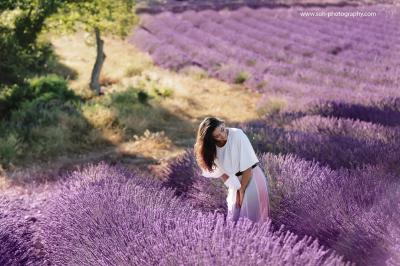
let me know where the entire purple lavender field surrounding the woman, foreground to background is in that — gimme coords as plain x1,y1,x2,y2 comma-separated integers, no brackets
0,1,400,266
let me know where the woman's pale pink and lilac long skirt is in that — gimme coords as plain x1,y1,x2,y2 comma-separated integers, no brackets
227,165,270,222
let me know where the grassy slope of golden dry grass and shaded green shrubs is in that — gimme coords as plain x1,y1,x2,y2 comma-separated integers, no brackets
2,30,261,186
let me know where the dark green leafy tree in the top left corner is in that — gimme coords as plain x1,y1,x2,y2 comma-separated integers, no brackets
0,0,74,84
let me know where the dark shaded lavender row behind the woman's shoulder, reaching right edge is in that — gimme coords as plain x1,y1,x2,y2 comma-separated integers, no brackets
241,97,400,170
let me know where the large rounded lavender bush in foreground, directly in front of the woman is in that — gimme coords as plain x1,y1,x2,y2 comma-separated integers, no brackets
42,164,349,265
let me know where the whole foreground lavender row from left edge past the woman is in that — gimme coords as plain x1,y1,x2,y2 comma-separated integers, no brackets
0,161,349,265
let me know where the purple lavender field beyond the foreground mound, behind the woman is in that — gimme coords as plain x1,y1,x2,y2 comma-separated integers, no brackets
130,1,400,265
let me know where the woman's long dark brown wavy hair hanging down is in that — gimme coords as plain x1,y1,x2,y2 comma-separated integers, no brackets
194,116,225,172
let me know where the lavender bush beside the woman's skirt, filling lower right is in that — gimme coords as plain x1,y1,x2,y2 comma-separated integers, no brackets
262,154,400,265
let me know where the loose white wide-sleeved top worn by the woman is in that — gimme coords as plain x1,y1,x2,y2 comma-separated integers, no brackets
202,127,259,209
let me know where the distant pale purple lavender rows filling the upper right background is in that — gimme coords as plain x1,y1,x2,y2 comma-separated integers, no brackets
130,6,400,106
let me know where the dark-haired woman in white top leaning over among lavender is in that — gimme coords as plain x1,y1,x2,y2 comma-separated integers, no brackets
194,117,269,222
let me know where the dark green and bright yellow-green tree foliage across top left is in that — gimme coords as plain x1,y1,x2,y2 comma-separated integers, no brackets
0,0,137,84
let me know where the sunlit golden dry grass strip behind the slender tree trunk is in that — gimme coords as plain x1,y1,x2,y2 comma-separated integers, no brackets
52,33,261,121
